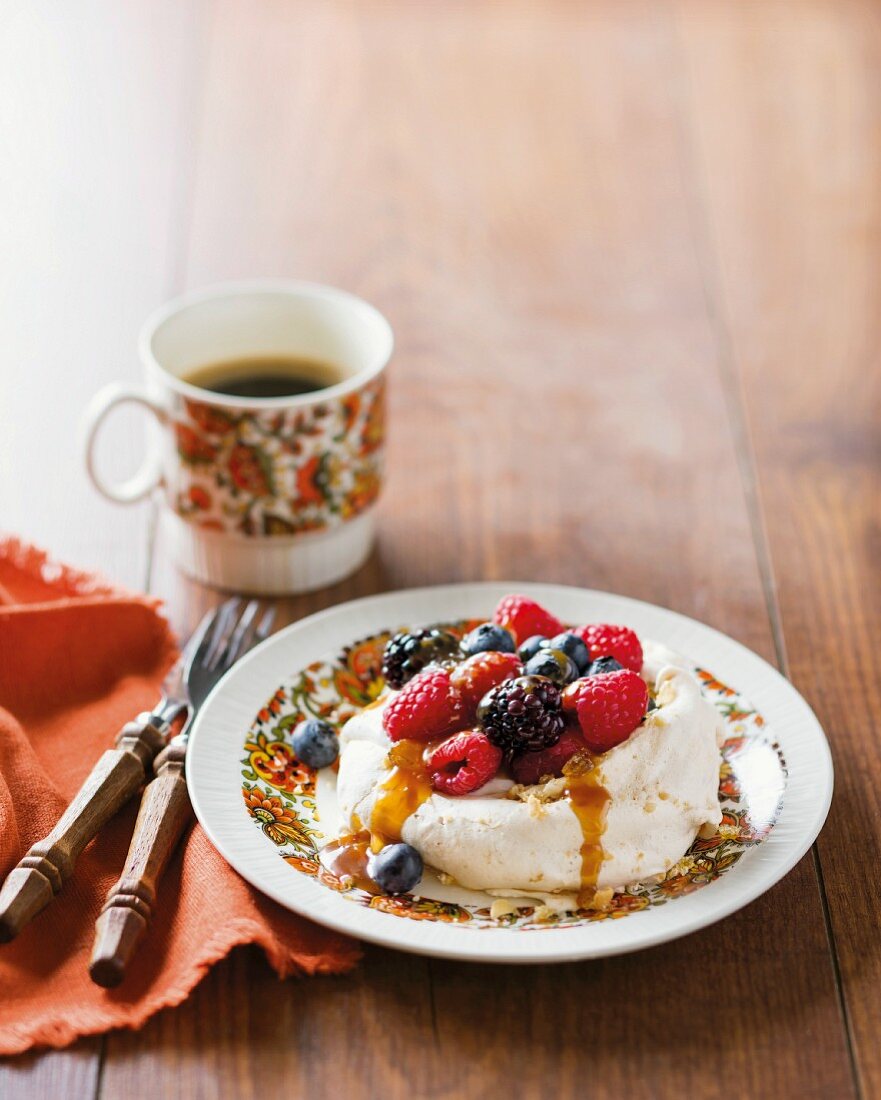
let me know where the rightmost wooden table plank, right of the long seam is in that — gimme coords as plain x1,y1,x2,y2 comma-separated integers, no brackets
679,2,881,1097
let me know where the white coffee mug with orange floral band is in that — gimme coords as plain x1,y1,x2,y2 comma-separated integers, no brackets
84,281,394,595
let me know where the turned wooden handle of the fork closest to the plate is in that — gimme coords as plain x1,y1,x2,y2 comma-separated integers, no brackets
89,744,192,988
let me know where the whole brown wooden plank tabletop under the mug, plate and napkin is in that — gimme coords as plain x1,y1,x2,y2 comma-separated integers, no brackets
0,0,881,1100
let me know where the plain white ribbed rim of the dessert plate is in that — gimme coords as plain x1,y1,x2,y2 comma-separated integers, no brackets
187,581,834,963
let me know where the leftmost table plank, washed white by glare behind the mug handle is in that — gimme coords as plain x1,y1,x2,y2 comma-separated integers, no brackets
0,0,200,1100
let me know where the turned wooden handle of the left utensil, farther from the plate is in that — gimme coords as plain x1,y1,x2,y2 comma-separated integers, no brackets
0,714,165,943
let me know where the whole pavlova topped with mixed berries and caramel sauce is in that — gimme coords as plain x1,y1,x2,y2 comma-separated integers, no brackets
303,595,722,911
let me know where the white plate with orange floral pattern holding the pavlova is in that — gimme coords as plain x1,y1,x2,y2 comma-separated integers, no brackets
187,582,833,963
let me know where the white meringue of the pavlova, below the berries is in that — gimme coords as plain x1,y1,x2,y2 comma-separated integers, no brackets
337,642,722,898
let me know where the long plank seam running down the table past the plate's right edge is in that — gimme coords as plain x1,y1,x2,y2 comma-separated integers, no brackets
668,9,863,1097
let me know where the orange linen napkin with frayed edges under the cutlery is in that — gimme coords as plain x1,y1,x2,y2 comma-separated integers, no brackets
0,539,359,1054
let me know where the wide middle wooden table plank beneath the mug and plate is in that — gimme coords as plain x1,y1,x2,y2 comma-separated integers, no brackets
101,0,855,1098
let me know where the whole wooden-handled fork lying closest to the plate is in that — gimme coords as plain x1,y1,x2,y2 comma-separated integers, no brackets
89,600,275,988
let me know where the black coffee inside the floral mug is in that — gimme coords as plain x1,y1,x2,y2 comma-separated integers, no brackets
181,355,344,397
